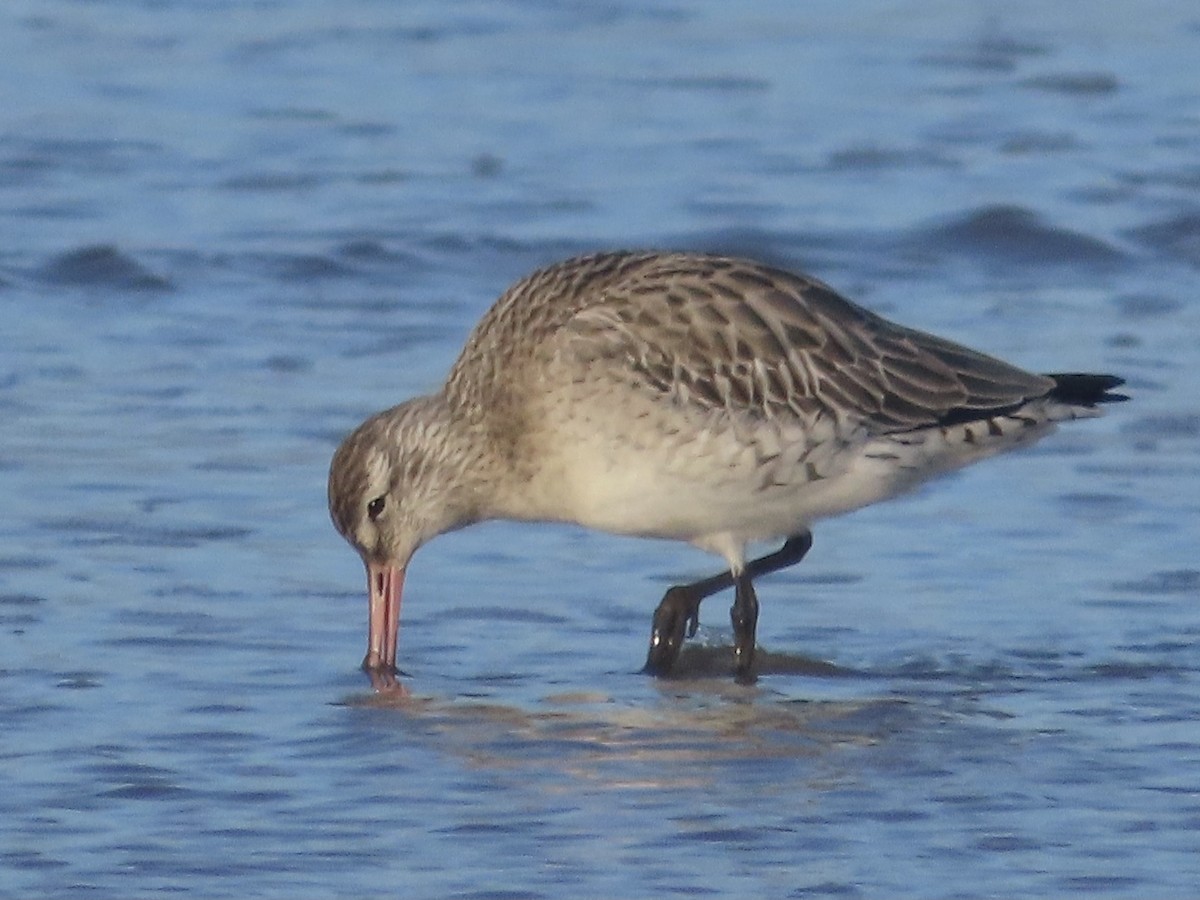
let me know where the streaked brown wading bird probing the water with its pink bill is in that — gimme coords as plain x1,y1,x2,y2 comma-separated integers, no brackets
329,253,1122,674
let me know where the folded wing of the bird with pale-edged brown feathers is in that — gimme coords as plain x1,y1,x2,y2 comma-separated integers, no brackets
552,254,1054,433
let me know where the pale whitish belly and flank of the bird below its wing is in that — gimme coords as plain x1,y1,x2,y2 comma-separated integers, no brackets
520,398,1052,564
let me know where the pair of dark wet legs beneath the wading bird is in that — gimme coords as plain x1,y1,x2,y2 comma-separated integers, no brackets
643,532,812,676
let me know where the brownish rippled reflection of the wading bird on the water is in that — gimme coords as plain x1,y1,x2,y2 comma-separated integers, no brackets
328,647,917,788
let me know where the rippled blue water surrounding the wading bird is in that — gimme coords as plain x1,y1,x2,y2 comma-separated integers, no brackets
0,0,1200,900
